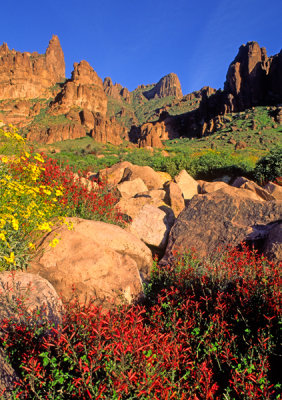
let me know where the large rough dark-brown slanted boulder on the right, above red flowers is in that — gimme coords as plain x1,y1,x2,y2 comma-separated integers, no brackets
162,187,282,263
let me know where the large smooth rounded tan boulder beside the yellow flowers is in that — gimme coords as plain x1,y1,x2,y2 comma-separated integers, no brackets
28,218,152,306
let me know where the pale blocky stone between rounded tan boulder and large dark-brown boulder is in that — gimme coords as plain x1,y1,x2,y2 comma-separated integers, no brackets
127,204,175,250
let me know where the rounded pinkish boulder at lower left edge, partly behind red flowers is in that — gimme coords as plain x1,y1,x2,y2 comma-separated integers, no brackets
0,271,63,329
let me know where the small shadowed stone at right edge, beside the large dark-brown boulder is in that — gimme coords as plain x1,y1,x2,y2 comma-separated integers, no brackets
262,223,282,263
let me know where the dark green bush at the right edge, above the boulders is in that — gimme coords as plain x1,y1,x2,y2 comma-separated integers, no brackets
254,146,282,184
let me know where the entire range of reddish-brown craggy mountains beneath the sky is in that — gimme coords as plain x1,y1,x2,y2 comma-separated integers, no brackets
0,36,282,147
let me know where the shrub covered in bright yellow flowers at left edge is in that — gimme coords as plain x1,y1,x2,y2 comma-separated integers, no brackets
0,128,63,270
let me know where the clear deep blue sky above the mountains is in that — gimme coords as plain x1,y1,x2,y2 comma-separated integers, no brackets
0,0,282,94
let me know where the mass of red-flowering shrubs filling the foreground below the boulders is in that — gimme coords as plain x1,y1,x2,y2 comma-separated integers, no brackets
1,245,281,400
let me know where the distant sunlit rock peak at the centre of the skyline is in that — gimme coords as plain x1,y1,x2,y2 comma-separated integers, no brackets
143,73,183,100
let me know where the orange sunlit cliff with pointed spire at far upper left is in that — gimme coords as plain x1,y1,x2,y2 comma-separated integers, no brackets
0,36,65,100
